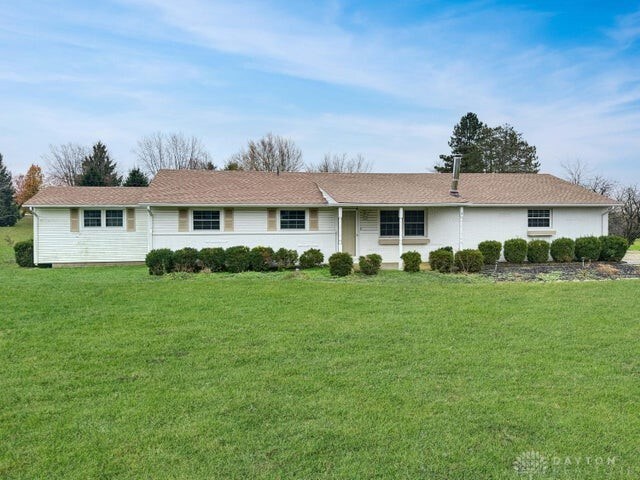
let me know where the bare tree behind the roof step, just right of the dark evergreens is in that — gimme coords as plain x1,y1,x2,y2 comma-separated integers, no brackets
134,132,215,175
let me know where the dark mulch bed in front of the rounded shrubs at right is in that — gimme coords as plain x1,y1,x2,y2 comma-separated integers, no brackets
482,262,640,282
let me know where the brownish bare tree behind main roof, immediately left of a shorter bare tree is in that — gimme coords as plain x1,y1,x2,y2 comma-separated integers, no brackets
227,133,303,172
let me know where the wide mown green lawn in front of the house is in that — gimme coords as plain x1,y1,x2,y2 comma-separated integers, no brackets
0,219,640,479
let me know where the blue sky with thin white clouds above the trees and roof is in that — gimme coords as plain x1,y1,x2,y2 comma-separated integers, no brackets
0,0,640,183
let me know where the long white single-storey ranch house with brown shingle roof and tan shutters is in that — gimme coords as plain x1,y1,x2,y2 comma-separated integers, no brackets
27,170,615,266
